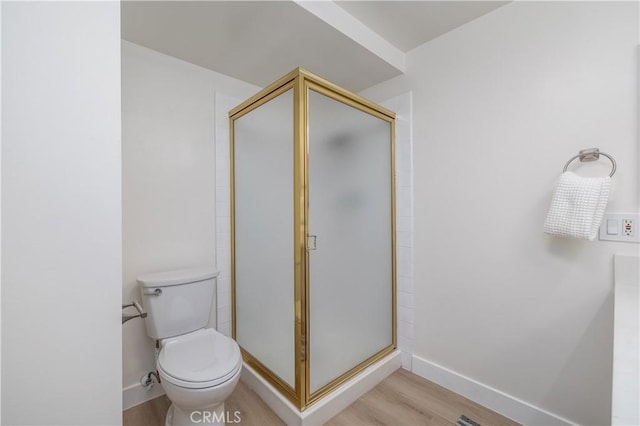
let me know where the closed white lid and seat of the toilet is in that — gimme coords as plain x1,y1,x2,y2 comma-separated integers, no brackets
158,328,242,388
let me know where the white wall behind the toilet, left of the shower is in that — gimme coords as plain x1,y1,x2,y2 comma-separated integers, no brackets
122,41,259,408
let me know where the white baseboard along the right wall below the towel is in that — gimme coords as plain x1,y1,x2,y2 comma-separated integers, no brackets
412,355,575,426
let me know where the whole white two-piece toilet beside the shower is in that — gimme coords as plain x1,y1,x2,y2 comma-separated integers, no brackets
138,268,242,426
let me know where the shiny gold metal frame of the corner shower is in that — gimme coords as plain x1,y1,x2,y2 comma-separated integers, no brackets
229,68,397,411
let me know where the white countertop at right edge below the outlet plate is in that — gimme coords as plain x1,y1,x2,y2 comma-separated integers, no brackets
611,255,640,425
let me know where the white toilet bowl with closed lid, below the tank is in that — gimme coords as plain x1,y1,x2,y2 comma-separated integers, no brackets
156,329,242,426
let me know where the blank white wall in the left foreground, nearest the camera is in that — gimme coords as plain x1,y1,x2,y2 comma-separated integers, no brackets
2,2,122,425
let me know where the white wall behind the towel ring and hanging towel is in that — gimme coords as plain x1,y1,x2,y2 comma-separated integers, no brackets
364,2,639,424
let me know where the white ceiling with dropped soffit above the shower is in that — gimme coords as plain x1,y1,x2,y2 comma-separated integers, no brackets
121,0,506,92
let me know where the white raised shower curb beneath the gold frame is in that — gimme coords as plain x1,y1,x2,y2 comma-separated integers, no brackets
241,351,401,426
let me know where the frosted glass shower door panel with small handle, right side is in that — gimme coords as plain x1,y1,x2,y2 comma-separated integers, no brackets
308,90,393,393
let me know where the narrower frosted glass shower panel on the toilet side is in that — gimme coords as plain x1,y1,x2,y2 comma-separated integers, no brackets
233,89,295,388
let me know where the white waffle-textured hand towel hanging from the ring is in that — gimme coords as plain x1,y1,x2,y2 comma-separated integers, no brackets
544,172,611,241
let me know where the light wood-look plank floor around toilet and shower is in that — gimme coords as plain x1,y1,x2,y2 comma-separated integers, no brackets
123,369,518,426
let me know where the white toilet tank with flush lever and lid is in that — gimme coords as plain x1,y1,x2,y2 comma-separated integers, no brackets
137,267,218,339
